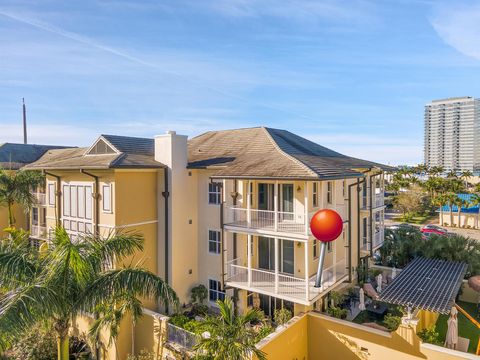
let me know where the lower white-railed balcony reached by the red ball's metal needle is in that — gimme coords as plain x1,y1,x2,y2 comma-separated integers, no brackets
226,259,348,305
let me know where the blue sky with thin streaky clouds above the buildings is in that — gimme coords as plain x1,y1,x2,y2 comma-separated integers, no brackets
0,0,480,164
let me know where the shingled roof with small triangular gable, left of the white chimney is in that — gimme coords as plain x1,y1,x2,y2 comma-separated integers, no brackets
26,135,164,170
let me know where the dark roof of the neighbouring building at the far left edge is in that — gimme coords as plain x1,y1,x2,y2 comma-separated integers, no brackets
0,143,71,170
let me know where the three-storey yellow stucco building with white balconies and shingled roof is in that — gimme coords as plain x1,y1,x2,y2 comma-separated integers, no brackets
18,127,389,359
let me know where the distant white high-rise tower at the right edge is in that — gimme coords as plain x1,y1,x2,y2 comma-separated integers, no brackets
424,96,480,171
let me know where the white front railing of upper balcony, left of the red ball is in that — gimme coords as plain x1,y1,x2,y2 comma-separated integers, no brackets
225,206,308,234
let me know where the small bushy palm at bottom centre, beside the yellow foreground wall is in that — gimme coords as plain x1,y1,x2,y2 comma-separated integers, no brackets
195,298,266,360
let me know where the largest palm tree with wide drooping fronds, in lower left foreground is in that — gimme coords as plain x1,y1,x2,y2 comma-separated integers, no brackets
0,227,178,360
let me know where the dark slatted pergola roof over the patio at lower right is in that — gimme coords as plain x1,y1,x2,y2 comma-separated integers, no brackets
379,257,467,314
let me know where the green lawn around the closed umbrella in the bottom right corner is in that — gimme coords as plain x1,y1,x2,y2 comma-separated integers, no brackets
436,301,480,354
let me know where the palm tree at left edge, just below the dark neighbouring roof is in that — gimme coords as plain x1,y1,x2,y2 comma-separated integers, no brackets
0,169,45,227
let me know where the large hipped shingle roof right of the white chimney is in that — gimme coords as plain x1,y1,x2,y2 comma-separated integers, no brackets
188,127,393,179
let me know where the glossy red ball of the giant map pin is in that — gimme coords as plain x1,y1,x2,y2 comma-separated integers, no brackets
310,209,343,242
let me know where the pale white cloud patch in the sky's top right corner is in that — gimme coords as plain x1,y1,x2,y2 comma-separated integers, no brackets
430,1,480,60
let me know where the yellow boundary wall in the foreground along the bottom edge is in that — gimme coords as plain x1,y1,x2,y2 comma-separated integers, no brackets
261,312,470,360
